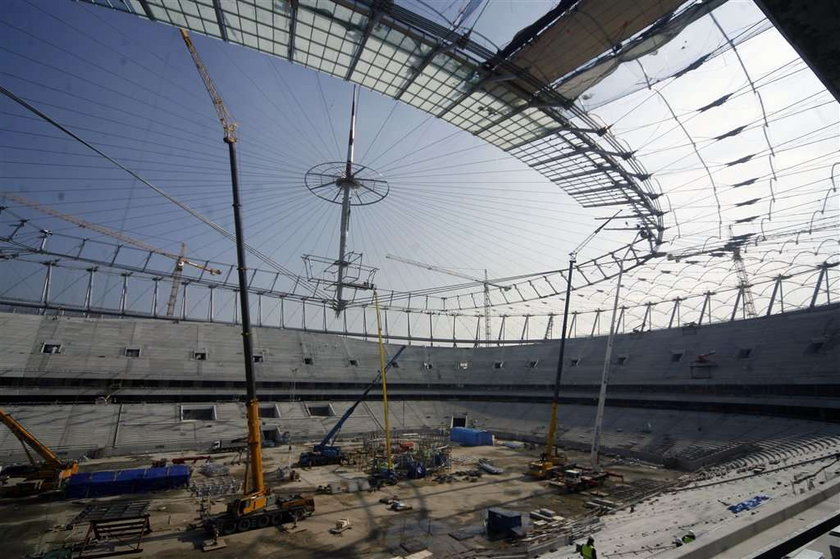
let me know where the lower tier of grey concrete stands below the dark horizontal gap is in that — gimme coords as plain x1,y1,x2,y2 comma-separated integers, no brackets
0,402,840,461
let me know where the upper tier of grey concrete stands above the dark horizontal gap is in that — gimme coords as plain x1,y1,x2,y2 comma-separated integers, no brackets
0,305,840,388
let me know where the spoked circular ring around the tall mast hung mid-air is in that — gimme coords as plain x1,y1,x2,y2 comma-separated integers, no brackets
304,161,391,206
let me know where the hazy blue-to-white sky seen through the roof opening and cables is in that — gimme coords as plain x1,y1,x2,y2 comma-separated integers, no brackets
0,0,836,336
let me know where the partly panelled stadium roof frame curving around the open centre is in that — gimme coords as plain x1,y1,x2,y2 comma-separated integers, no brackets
0,0,840,340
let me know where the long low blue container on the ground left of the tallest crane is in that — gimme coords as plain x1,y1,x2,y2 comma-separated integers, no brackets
64,465,190,499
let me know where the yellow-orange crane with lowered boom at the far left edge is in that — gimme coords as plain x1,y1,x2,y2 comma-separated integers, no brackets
0,409,79,496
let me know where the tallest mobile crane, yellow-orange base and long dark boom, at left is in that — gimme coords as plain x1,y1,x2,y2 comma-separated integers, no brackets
180,29,315,535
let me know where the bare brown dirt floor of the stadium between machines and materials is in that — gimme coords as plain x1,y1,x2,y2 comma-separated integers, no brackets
0,445,680,559
